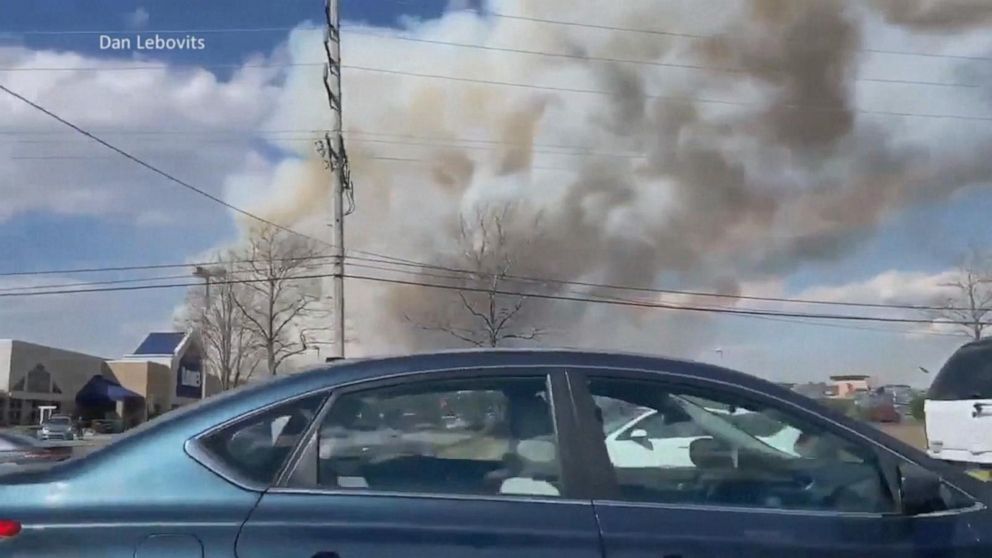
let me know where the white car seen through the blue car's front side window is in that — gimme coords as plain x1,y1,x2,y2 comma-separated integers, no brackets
606,408,801,468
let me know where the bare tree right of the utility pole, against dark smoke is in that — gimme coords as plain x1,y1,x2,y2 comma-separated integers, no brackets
406,205,544,347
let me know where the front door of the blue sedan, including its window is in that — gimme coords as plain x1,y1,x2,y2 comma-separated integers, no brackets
568,369,992,558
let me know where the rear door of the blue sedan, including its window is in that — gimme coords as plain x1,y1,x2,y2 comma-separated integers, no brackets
237,368,601,558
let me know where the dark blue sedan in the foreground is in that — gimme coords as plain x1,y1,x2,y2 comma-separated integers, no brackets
0,350,992,558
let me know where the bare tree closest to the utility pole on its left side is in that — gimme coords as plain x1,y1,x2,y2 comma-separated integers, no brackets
232,226,327,375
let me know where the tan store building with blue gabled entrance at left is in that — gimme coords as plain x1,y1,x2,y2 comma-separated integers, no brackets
0,332,220,427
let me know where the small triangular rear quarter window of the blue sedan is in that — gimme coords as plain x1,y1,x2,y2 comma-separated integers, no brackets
201,395,326,485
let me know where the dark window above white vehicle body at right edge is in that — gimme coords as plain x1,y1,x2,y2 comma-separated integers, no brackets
927,341,992,401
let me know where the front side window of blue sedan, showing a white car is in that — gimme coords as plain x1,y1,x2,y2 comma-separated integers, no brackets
589,378,895,513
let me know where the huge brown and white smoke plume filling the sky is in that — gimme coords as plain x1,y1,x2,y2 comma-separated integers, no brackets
238,0,992,356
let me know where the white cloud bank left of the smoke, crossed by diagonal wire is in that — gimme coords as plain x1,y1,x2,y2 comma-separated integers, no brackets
0,47,277,223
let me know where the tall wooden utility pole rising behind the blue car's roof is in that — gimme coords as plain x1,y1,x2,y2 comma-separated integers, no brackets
317,0,355,358
